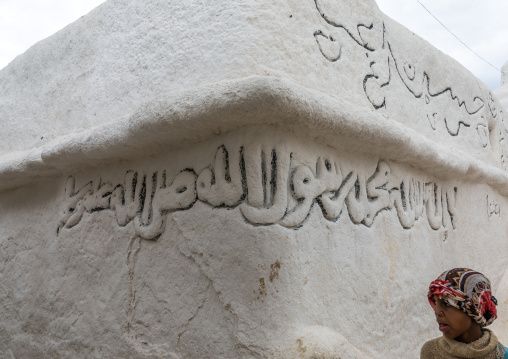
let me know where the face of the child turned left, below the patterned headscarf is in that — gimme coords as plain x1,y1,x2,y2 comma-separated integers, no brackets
434,296,481,343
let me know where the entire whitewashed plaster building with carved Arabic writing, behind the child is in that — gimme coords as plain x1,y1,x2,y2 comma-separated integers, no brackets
0,0,508,359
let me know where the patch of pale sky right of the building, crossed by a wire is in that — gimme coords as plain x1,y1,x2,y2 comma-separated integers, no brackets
377,0,508,90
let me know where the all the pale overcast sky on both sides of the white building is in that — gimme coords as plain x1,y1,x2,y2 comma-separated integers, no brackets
0,0,508,90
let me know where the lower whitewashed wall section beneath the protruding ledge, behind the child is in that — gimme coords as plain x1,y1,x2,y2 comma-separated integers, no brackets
0,127,508,358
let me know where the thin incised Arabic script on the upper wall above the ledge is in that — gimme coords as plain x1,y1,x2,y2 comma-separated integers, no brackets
313,0,492,147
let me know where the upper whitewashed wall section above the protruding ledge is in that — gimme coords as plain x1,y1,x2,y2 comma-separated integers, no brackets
0,0,504,160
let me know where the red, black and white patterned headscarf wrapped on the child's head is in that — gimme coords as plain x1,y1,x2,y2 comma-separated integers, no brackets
428,268,497,327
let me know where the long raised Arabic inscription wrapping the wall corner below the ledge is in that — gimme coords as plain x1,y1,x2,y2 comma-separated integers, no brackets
57,145,457,239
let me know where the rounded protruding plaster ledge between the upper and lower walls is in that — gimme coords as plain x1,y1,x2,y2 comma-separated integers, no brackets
0,76,508,195
